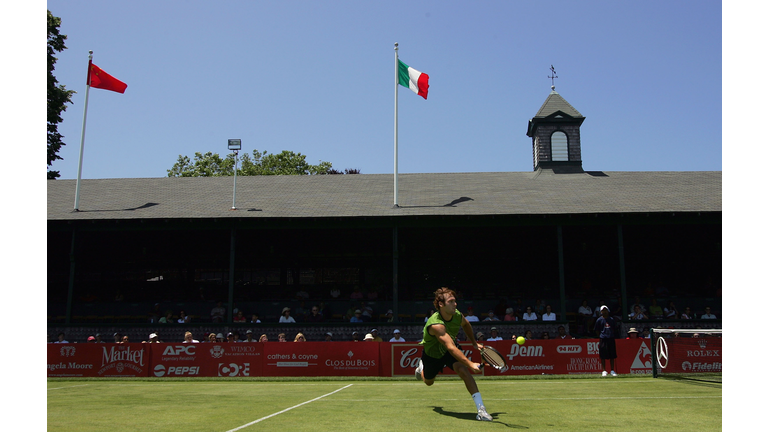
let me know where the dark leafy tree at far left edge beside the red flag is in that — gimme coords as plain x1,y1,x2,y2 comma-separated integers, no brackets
48,11,75,180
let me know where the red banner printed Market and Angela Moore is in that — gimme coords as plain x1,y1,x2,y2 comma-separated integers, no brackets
48,343,149,377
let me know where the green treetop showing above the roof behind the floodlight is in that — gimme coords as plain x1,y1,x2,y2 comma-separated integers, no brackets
168,150,360,177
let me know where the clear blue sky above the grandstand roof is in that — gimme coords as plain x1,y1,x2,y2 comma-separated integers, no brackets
47,0,723,179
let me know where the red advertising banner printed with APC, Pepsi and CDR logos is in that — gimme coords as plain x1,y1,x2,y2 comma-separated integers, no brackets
150,342,264,377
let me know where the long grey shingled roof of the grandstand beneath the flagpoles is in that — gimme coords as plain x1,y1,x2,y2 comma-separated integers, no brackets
47,170,722,221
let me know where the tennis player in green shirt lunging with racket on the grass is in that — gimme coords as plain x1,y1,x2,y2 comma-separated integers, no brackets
416,288,493,421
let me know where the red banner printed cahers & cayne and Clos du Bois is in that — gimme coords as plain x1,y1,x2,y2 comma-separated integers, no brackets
262,342,383,376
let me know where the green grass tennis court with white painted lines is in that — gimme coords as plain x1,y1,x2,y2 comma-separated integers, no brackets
47,376,722,432
